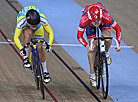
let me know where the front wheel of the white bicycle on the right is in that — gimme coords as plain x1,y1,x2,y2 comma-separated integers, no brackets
101,53,109,99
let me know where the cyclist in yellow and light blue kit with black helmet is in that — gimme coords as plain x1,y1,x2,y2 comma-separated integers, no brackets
14,6,54,83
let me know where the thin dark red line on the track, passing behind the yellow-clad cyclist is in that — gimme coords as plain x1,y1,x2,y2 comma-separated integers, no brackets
0,29,58,102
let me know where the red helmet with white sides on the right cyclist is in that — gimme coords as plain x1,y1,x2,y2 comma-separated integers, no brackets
88,6,102,21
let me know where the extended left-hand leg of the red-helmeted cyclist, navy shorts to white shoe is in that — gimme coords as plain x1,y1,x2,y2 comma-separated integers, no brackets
86,25,97,86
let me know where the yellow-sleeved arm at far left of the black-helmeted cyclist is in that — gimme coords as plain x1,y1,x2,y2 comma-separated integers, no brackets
14,27,23,50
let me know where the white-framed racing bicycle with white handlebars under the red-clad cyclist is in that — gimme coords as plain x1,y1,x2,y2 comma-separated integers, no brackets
91,27,119,99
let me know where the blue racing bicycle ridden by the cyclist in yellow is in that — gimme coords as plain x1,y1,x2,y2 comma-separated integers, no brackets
23,38,47,99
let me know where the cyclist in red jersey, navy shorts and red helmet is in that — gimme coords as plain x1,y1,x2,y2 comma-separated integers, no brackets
77,2,121,86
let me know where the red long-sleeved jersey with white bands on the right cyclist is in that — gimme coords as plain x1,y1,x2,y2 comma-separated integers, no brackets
77,2,121,47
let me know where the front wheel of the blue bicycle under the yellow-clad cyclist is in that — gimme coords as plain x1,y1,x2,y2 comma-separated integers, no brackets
35,56,45,99
